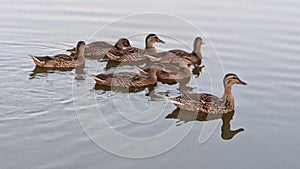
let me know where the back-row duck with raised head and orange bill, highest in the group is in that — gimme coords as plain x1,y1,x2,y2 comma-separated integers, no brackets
106,33,165,63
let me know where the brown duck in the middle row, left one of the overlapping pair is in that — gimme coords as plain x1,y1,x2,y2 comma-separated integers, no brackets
91,65,163,89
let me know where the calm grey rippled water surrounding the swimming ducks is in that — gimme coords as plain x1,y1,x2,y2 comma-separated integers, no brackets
0,0,300,169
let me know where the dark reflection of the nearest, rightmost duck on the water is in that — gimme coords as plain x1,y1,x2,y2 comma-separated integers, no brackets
165,108,244,140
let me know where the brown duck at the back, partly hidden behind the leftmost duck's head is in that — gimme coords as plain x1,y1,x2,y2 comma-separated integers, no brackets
67,38,131,59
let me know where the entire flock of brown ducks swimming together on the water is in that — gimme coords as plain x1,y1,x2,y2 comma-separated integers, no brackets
30,34,247,114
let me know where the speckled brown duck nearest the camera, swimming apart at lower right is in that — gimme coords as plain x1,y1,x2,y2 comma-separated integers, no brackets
166,73,247,114
